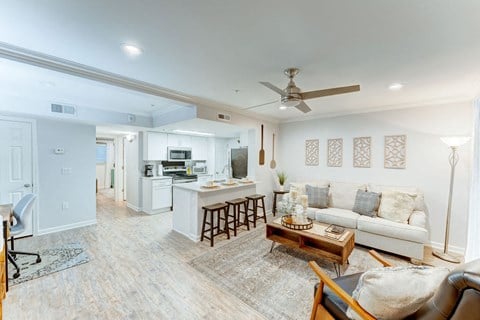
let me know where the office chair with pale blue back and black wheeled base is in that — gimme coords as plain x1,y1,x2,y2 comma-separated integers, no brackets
8,193,42,279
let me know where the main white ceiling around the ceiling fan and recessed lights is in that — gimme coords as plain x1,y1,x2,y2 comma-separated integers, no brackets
0,0,480,120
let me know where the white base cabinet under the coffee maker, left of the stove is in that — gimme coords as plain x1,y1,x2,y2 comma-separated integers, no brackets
142,177,172,214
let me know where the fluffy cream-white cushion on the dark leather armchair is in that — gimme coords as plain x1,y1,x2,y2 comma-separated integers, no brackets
347,266,449,320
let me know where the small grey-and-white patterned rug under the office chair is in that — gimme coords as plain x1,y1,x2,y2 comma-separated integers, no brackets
8,243,89,286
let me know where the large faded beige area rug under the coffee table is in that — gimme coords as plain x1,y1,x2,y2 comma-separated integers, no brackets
190,226,409,320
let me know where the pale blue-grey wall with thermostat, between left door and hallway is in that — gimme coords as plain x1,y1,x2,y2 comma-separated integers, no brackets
37,119,96,234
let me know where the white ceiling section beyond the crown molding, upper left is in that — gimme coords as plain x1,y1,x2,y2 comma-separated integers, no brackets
0,59,186,116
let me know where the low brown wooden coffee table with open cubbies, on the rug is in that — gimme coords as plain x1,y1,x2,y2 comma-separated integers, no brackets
266,218,355,277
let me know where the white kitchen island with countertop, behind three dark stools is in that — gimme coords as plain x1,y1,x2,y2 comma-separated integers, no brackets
173,182,258,241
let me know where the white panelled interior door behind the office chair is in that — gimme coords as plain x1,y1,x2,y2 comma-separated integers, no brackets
0,119,33,236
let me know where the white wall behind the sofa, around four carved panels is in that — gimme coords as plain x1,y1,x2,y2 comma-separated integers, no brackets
278,103,473,250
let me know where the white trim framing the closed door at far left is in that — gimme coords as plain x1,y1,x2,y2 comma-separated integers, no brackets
0,114,41,235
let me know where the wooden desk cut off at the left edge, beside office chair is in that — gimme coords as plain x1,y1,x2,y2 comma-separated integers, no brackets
0,204,13,320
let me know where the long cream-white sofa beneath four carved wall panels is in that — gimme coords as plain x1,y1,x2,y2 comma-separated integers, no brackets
290,181,428,260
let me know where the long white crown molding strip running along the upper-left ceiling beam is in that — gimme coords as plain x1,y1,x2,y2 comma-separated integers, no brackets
0,42,193,103
